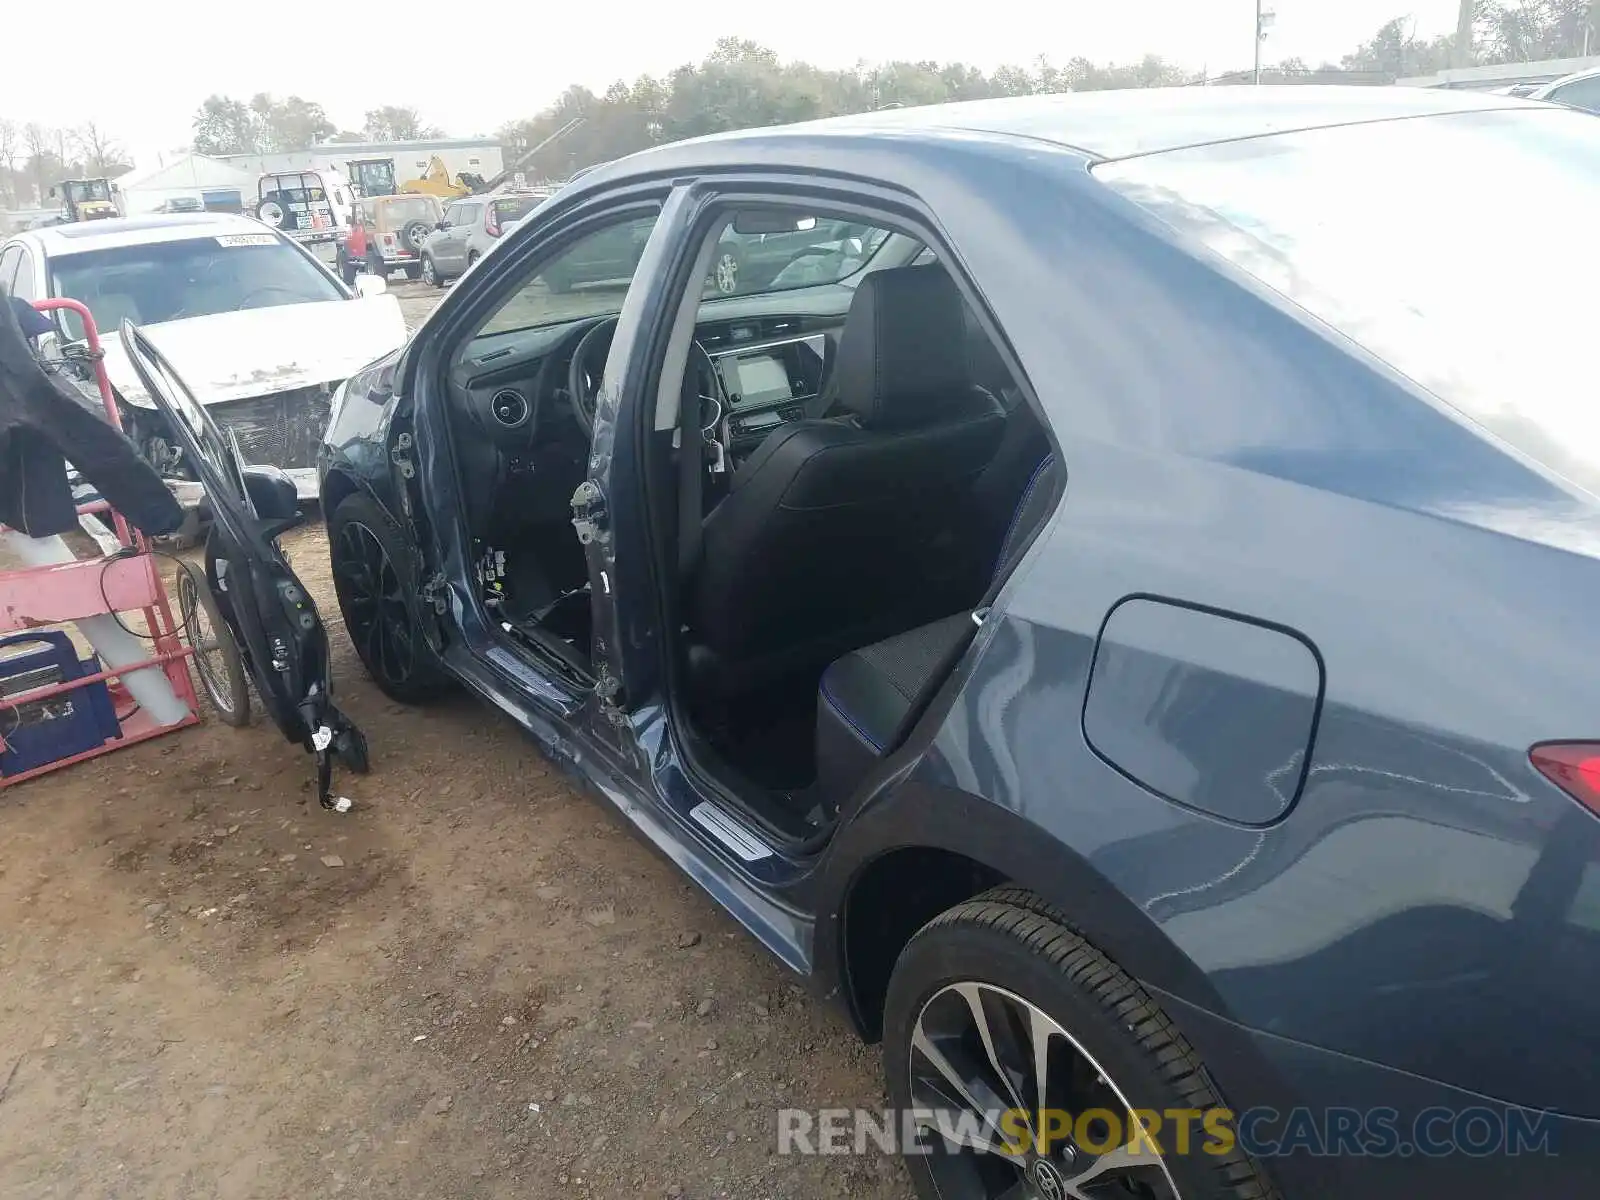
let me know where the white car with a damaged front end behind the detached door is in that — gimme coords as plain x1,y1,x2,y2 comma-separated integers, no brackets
0,213,406,504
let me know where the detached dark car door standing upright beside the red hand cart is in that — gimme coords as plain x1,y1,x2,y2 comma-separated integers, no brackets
122,322,366,811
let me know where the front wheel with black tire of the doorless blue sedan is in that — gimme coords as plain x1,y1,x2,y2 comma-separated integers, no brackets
328,493,450,704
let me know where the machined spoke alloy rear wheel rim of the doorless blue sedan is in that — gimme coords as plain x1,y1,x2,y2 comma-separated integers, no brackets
907,981,1181,1200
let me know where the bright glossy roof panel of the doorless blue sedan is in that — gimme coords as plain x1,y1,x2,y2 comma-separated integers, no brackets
630,85,1531,164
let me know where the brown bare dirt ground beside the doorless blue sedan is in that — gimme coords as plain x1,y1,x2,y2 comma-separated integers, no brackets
0,285,909,1200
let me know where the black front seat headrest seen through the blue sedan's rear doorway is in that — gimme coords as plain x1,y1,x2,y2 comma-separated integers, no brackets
834,266,971,429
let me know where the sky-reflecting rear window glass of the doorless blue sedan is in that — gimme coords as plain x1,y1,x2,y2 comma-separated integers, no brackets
1094,109,1600,493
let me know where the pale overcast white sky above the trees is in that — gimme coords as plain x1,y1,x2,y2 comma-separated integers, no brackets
0,0,1458,166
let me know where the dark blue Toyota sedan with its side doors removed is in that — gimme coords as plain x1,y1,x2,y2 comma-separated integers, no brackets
121,88,1600,1200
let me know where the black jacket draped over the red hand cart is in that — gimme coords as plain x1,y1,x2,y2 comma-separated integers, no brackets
0,289,184,538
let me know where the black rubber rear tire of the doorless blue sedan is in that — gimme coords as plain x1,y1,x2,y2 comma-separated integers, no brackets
883,888,1278,1200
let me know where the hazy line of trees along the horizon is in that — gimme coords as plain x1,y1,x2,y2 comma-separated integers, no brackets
0,0,1600,208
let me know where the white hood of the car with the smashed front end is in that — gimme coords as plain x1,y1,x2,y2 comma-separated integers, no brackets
104,294,406,408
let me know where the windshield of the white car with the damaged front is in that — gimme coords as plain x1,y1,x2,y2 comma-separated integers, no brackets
50,234,344,339
